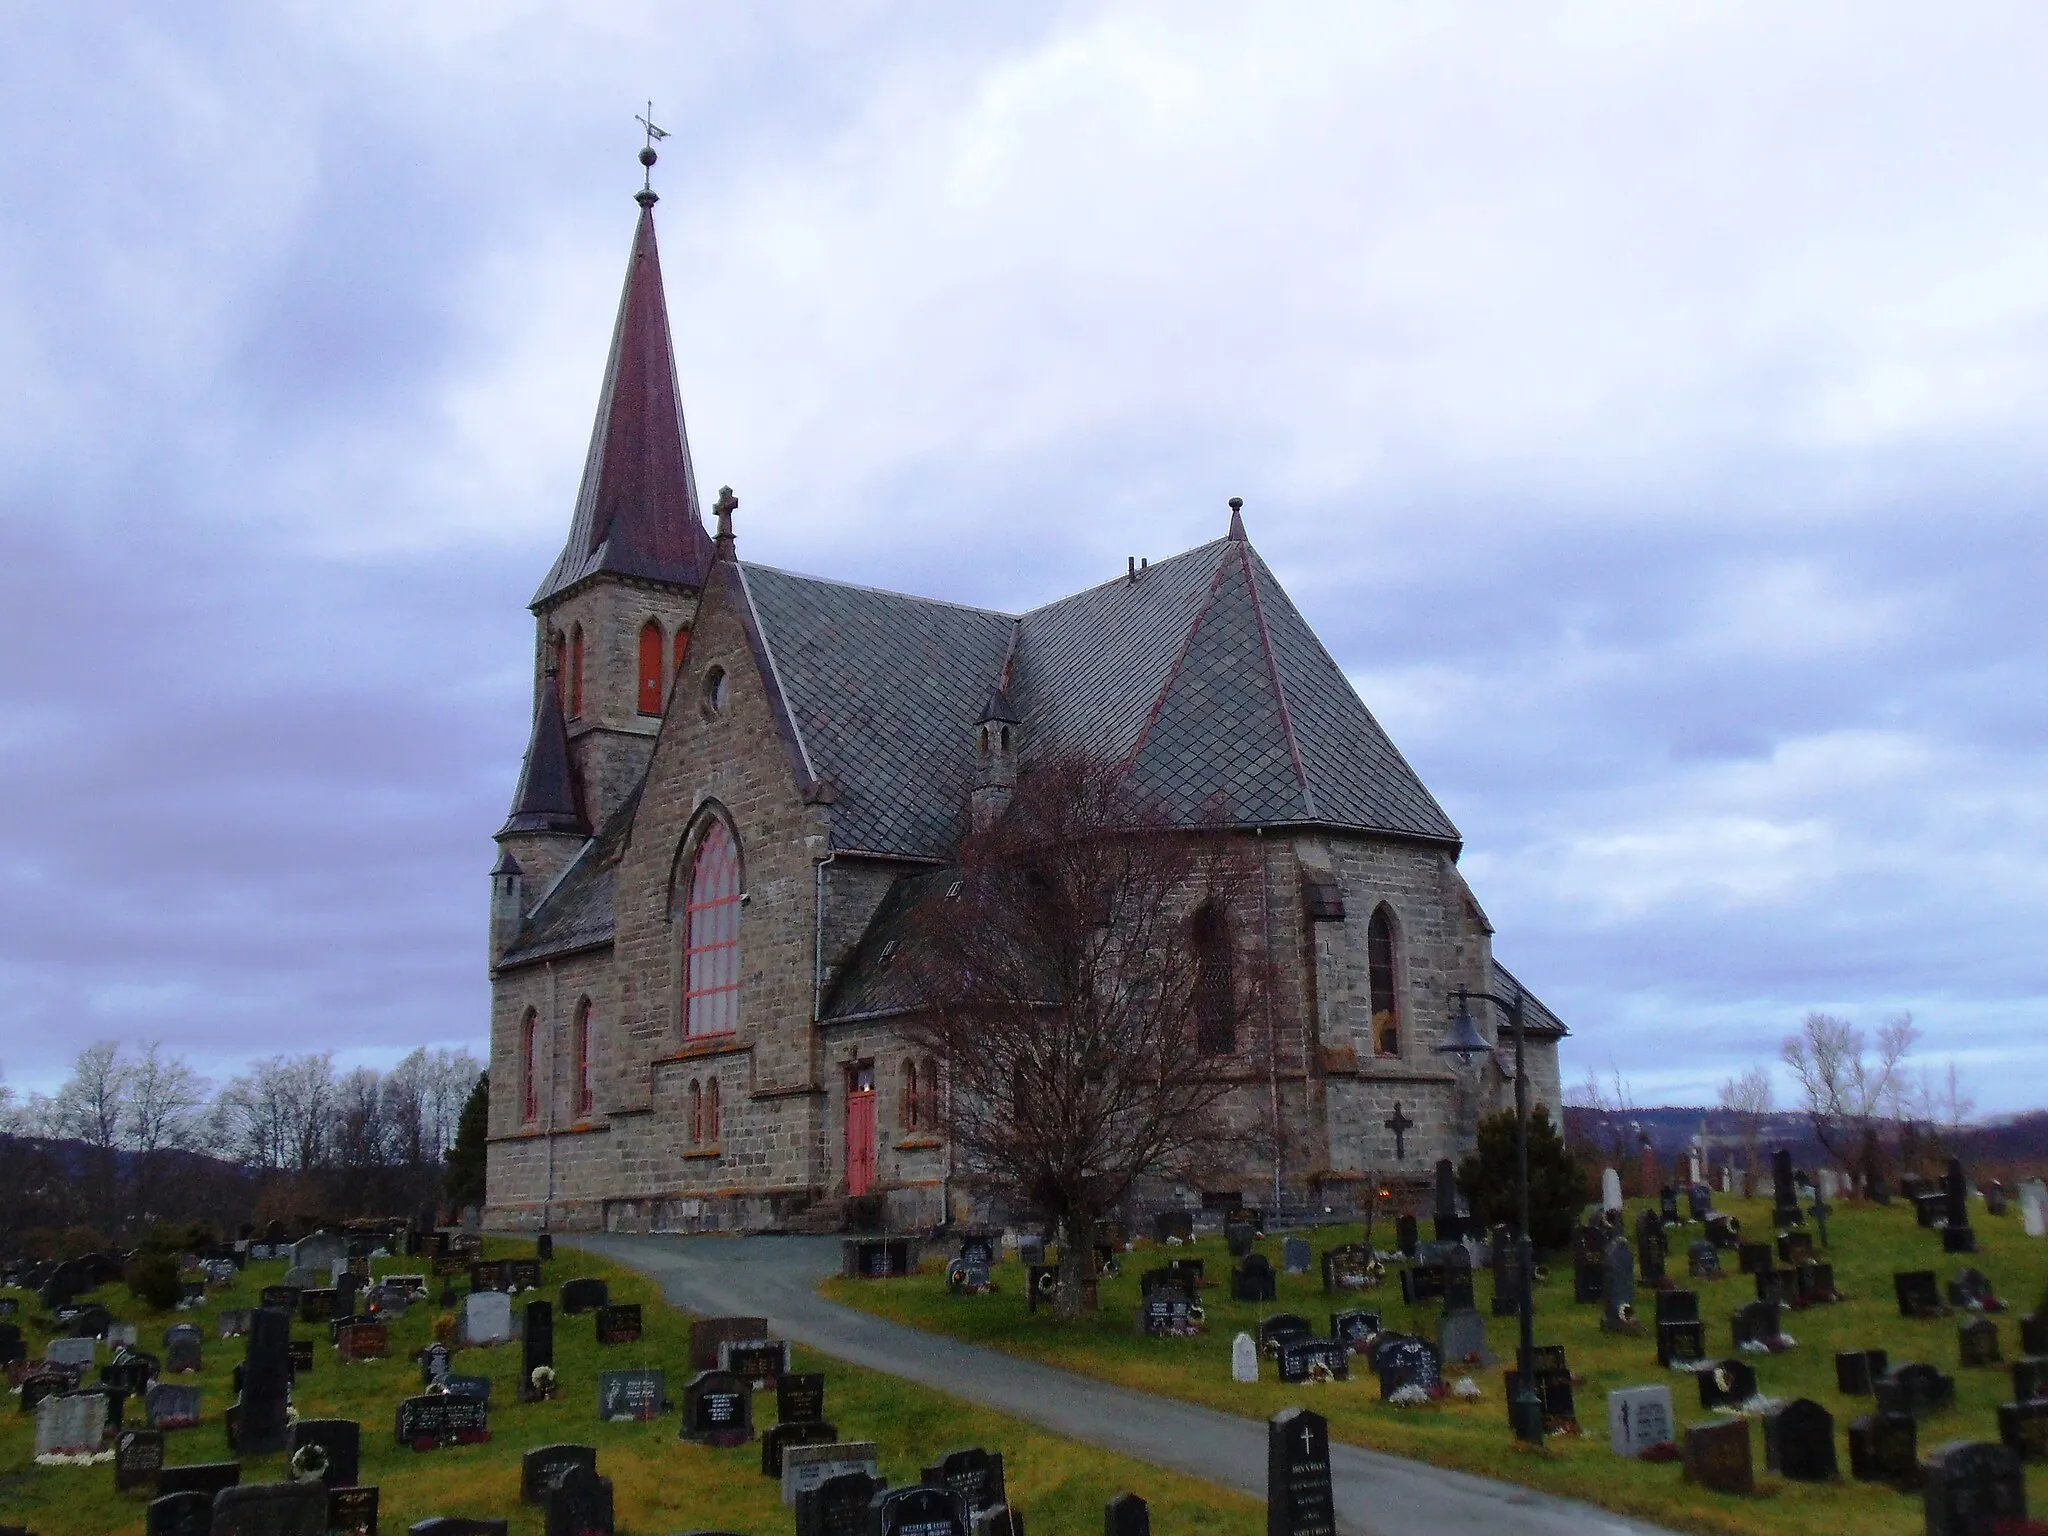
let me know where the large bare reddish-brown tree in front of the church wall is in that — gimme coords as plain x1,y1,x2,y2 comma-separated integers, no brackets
905,758,1268,1317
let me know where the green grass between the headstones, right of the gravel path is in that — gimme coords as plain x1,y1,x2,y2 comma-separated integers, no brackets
823,1200,2048,1536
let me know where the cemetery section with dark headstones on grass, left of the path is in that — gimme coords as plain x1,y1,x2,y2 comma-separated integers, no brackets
0,1237,1264,1536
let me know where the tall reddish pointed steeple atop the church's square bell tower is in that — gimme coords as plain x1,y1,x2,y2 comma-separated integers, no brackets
532,186,711,606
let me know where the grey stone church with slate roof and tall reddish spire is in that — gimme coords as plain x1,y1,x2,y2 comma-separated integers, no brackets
485,165,1567,1231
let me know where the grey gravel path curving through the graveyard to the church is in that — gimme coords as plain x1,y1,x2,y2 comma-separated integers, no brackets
559,1235,1669,1536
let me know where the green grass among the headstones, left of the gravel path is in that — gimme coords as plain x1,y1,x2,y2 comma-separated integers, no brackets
0,1239,1264,1536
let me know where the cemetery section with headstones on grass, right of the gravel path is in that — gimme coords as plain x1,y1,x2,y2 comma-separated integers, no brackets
823,1174,2048,1536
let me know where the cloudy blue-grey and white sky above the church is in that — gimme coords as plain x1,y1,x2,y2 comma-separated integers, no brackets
0,0,2048,1110
